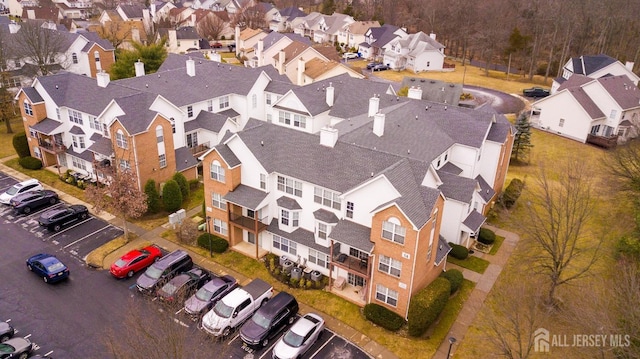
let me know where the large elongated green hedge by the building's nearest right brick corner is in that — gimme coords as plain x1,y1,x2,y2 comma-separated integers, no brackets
408,277,451,337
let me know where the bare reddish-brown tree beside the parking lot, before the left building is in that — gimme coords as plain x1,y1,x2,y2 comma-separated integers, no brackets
85,160,147,241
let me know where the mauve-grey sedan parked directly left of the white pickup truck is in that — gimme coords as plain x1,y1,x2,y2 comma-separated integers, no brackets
184,275,238,319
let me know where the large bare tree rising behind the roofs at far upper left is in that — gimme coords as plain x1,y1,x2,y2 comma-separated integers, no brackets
12,21,67,76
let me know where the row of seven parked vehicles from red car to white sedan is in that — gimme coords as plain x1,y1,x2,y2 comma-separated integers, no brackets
111,246,325,359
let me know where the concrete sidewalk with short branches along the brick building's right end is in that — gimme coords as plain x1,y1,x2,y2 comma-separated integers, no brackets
432,225,520,359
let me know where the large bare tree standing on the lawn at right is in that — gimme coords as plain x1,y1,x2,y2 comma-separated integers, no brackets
523,159,604,307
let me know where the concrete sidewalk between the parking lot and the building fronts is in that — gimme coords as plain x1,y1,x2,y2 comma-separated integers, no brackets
0,162,398,359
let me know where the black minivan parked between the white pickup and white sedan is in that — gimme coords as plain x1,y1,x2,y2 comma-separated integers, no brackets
240,292,298,347
